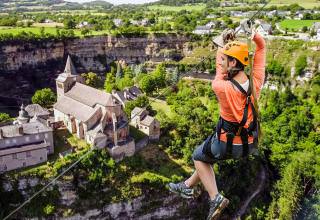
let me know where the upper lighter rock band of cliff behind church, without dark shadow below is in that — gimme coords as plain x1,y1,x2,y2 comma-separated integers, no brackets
0,35,187,73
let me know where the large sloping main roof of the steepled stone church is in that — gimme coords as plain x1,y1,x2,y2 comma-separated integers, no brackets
65,82,115,108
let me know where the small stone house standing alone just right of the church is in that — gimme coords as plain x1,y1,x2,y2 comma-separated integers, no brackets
130,107,160,140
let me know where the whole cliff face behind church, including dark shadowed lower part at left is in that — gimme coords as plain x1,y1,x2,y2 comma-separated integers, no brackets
0,34,187,105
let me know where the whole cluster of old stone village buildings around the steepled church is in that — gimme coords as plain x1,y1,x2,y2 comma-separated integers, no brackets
0,56,160,172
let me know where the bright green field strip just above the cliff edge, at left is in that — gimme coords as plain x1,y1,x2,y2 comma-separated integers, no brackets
0,26,110,36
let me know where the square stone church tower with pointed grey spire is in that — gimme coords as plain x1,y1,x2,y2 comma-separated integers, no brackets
56,55,83,99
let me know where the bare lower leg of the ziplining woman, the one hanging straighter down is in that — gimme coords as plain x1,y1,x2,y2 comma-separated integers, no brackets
191,160,218,199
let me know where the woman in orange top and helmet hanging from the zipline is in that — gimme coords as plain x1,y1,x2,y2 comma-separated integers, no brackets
168,20,266,220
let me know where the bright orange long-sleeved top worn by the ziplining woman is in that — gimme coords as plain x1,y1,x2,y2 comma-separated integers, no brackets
212,33,266,144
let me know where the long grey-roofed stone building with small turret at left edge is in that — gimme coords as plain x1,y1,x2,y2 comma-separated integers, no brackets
0,105,54,173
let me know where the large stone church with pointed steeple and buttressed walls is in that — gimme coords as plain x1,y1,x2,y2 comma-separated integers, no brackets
53,56,135,157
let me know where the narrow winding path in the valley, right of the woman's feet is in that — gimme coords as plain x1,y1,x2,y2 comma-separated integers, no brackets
232,165,266,220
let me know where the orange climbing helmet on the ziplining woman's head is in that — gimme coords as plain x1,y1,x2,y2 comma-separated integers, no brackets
221,41,249,66
